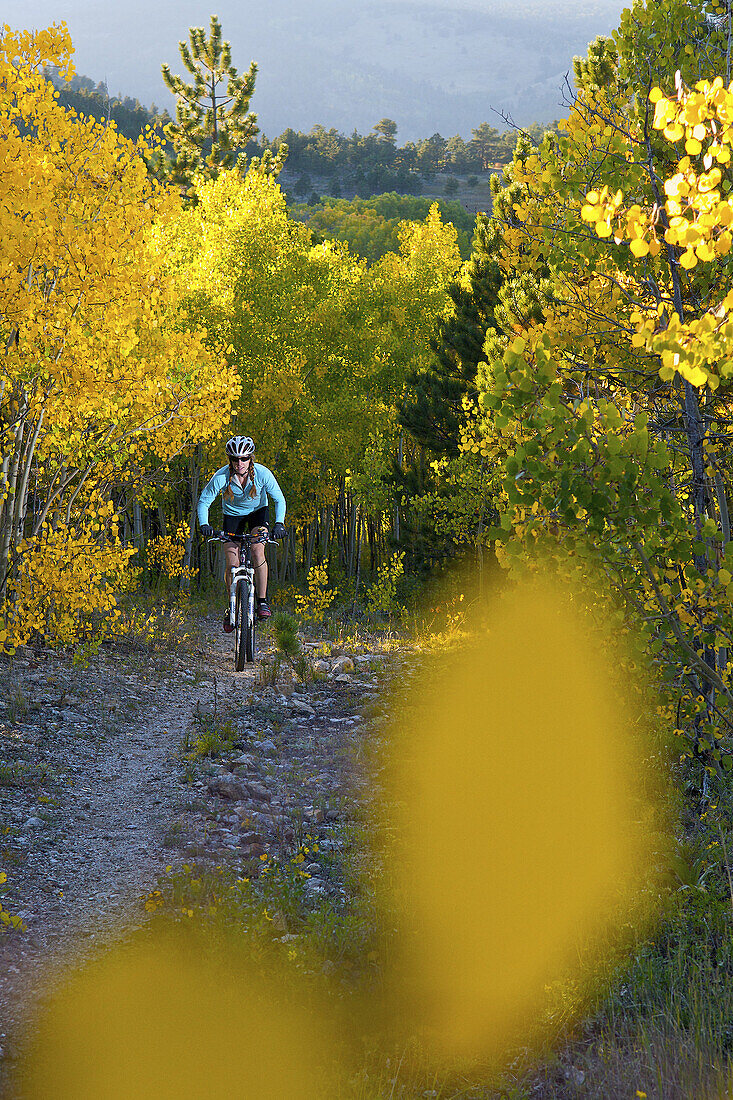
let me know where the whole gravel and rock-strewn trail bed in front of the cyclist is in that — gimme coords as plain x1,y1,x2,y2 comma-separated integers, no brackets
0,617,385,1100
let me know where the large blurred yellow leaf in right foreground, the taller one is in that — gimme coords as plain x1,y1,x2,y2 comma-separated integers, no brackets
375,584,665,1059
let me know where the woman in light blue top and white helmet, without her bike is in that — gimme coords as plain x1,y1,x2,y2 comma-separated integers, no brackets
197,436,285,634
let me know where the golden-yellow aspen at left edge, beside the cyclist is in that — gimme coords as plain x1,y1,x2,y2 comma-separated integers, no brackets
0,24,236,645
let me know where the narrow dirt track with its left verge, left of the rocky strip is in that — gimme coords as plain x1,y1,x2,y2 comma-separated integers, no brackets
0,620,245,1058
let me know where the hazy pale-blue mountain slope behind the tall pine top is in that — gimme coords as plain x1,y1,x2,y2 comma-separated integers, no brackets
9,0,623,142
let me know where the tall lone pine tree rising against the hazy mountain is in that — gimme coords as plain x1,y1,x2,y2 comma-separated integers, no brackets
162,15,259,186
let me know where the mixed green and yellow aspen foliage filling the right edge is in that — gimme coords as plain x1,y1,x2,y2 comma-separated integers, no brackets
461,0,733,774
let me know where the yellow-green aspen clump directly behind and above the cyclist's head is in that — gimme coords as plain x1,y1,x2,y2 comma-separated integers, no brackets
169,169,460,523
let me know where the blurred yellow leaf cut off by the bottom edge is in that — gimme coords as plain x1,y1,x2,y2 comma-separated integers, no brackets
23,937,336,1100
